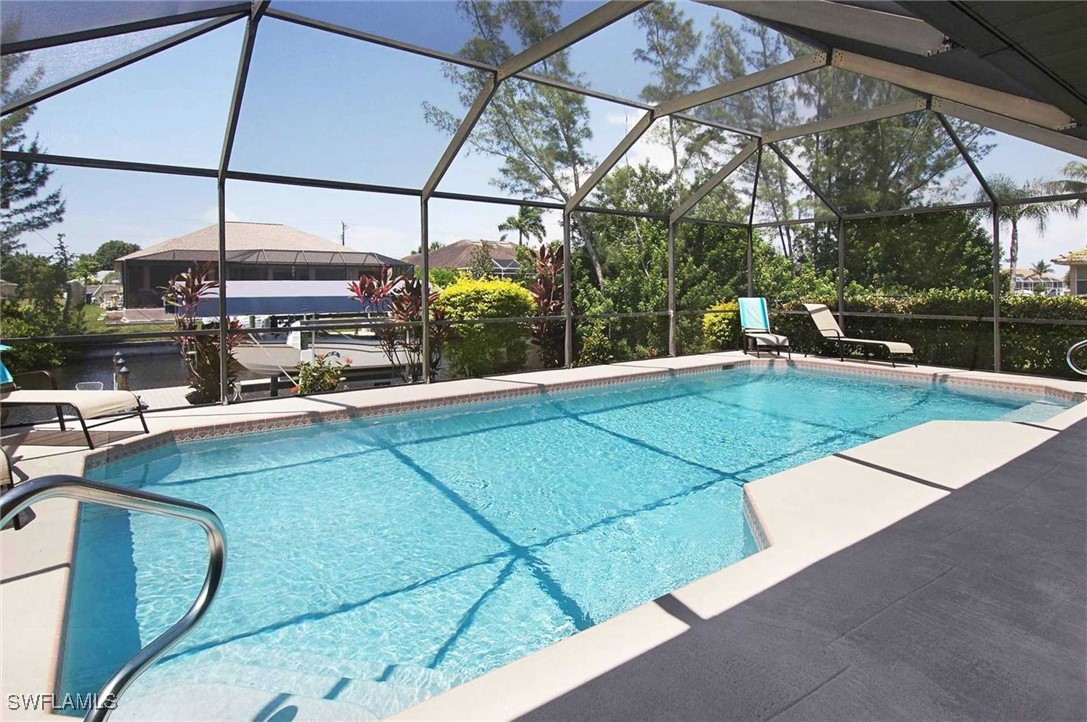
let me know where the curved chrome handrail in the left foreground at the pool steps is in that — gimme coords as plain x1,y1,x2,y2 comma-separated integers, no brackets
0,474,226,722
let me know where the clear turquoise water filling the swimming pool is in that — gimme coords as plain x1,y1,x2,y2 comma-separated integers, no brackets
62,370,1063,715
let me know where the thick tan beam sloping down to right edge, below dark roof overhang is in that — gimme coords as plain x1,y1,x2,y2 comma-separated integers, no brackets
830,50,1076,130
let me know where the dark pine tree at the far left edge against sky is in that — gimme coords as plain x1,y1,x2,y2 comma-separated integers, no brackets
0,54,64,257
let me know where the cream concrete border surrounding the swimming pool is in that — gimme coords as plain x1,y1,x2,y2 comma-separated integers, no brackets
0,352,1087,719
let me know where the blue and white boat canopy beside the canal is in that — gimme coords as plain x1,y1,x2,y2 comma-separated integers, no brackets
182,281,388,318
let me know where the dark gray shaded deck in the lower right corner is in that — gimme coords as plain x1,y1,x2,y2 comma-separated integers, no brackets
523,421,1087,720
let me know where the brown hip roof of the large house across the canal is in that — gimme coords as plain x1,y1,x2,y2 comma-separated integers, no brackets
117,221,403,265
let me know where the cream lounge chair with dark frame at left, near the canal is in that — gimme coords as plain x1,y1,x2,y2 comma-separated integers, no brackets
0,352,148,449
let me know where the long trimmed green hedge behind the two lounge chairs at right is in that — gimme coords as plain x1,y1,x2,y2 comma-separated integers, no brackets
702,289,1087,378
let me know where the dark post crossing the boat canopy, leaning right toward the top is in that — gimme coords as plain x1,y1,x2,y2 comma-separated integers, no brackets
217,0,270,406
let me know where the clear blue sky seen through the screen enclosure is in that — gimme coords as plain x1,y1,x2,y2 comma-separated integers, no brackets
16,2,1087,275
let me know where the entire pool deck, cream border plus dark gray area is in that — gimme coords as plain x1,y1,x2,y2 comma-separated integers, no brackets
0,352,1087,720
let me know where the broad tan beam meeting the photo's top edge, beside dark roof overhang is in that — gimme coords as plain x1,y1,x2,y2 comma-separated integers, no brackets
702,0,945,55
